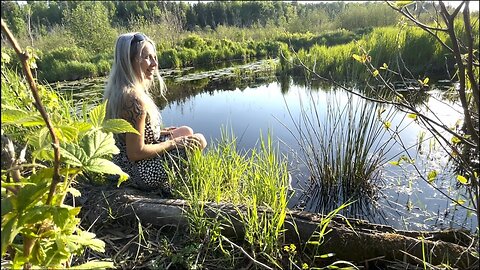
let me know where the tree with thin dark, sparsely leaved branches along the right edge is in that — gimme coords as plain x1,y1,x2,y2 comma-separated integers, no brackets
387,1,480,229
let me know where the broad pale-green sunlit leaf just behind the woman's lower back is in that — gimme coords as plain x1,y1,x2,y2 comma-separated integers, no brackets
81,130,120,159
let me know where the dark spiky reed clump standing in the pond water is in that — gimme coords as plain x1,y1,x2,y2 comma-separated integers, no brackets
284,88,394,216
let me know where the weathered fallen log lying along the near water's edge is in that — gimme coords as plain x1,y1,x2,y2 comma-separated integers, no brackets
80,187,478,269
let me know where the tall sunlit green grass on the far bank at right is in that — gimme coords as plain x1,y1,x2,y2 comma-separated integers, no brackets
282,27,453,80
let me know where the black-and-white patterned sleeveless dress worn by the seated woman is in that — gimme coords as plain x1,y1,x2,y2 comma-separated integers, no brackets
112,115,186,195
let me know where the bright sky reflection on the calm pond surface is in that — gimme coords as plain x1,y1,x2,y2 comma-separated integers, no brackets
162,77,475,230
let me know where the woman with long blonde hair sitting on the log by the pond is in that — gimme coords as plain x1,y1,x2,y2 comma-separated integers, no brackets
104,33,207,192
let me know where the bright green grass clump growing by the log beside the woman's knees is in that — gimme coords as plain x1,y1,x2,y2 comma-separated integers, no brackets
169,131,289,262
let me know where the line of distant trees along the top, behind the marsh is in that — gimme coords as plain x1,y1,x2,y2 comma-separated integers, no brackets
1,1,408,36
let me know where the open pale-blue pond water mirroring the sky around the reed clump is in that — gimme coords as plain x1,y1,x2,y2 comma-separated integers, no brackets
162,77,476,230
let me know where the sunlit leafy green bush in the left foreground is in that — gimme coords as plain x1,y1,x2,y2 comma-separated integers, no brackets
1,51,136,269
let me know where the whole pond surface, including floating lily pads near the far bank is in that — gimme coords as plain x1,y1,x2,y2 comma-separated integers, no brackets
53,59,477,230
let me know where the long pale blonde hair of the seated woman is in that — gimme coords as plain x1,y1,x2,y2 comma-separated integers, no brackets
103,32,166,131
